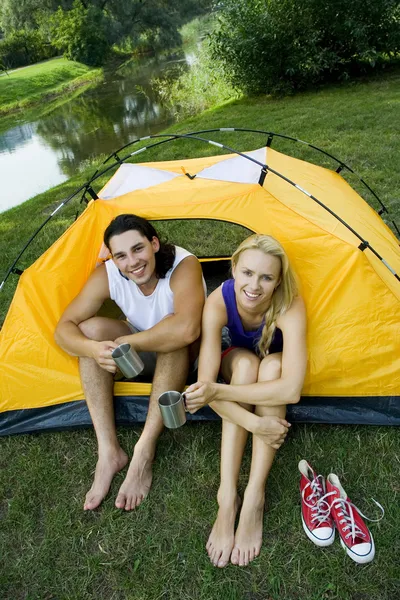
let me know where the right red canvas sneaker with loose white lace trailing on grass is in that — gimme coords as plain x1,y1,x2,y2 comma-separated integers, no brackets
326,473,384,564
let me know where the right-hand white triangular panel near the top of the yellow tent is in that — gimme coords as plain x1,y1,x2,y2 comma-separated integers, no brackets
197,148,267,183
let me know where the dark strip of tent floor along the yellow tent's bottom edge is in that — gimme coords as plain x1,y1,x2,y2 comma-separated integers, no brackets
0,396,400,436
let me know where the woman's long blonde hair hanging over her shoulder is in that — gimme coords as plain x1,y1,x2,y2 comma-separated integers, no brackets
232,235,298,357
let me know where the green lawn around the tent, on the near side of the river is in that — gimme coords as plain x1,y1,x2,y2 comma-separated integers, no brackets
0,73,400,600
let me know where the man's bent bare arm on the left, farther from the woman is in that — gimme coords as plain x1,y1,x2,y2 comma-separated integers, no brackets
54,265,110,357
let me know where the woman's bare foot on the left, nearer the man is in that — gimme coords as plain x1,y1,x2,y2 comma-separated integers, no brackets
206,496,240,567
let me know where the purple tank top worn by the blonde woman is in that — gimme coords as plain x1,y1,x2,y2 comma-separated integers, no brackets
222,279,283,354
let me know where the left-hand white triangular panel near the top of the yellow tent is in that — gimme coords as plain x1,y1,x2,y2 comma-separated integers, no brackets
99,164,182,200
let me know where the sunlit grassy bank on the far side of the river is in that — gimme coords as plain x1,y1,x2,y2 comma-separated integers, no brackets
0,58,103,117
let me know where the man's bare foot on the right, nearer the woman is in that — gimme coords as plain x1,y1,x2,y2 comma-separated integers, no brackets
115,444,155,510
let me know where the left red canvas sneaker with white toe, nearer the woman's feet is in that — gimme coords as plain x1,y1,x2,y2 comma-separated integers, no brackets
299,460,335,546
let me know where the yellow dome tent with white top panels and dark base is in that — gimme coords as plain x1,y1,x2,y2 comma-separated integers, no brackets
0,129,400,434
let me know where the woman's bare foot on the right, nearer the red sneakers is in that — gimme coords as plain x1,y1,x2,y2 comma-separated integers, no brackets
231,490,265,567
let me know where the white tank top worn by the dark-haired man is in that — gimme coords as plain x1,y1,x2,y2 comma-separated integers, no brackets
105,246,206,331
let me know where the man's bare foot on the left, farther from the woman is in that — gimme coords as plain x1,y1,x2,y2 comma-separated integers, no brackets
83,448,128,510
